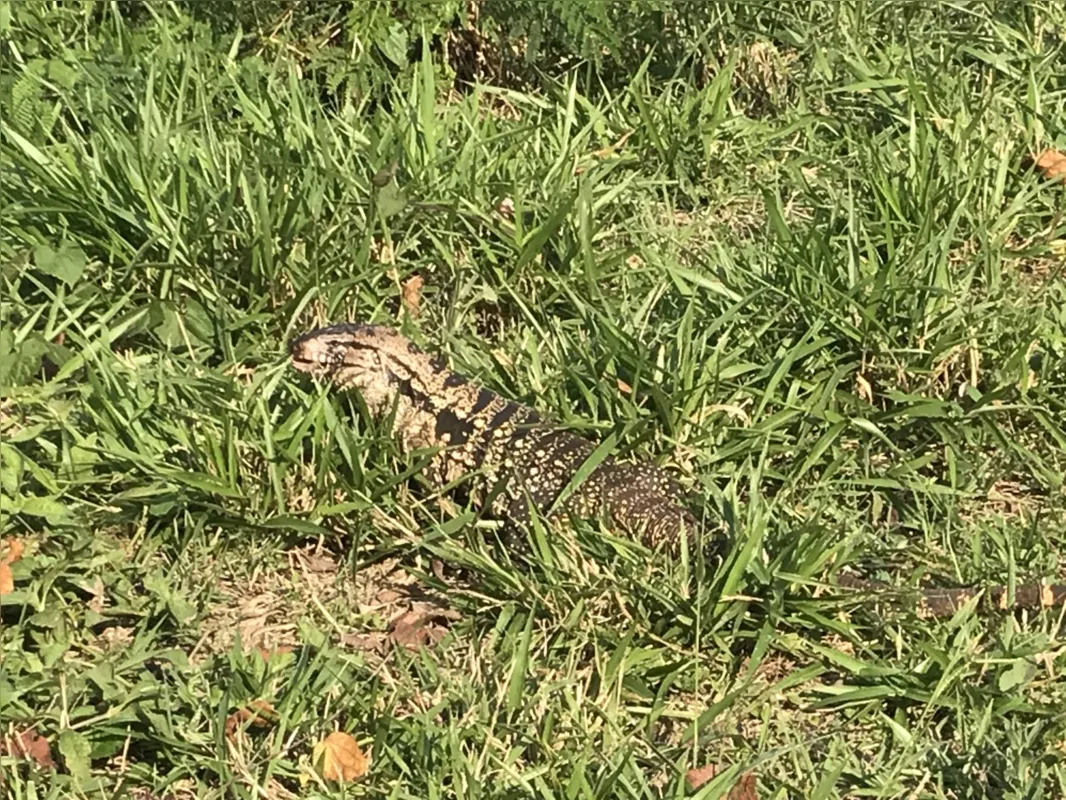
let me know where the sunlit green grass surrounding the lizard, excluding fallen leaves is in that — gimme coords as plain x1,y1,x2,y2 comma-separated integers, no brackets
0,0,1066,799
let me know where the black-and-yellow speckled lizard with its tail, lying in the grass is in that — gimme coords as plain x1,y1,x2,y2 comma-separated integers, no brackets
289,323,1066,617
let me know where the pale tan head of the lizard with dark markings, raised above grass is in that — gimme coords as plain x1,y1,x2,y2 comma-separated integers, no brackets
289,323,443,414
